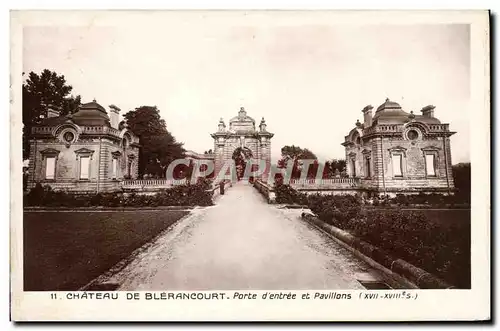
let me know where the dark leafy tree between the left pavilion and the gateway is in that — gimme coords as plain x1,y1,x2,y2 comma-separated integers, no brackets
124,106,185,177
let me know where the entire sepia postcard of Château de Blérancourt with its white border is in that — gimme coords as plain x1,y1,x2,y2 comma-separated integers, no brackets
10,10,491,322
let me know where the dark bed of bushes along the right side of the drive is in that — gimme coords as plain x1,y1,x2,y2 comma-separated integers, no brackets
308,191,470,288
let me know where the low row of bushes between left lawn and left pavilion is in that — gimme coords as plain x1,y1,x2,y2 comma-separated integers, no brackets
24,182,213,207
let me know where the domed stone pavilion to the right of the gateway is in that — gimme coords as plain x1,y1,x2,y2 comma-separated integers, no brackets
342,99,455,195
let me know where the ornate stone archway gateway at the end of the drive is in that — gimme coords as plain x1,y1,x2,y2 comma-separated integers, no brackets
211,107,274,179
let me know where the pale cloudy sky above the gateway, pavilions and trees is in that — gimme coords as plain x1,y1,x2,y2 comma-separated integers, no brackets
23,12,471,163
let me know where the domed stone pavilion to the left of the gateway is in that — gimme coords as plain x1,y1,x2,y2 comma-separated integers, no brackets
28,100,139,192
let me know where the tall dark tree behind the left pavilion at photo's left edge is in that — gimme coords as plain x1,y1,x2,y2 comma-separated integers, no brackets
23,69,81,159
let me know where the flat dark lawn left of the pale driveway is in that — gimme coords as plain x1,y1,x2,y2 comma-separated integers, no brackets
23,210,188,291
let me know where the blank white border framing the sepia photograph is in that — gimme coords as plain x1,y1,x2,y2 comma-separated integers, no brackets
11,11,491,321
